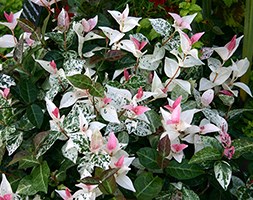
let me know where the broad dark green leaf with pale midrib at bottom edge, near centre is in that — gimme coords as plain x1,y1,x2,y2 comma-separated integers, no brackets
134,172,163,200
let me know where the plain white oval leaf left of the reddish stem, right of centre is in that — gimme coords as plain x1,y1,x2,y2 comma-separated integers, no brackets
164,57,180,78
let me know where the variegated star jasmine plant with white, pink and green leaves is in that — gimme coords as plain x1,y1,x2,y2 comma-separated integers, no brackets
0,0,253,200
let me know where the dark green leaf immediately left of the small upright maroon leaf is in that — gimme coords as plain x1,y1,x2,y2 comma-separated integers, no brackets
137,147,159,169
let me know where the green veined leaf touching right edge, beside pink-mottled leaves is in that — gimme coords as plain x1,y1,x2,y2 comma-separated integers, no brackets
232,139,253,159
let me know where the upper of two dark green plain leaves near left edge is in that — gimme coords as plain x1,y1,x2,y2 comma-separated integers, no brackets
19,80,38,103
